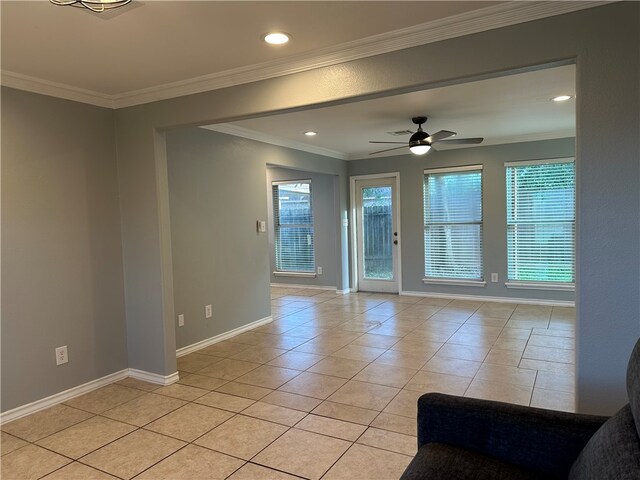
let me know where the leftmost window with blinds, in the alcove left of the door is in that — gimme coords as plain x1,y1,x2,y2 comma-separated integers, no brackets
273,180,315,273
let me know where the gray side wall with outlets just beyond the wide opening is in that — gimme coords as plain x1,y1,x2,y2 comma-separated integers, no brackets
166,128,344,348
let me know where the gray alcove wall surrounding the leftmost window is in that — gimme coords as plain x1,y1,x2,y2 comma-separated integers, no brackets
267,168,337,288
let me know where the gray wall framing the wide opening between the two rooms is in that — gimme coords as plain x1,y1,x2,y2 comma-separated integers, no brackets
109,2,640,413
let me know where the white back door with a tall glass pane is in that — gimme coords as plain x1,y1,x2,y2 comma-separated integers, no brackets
351,173,400,293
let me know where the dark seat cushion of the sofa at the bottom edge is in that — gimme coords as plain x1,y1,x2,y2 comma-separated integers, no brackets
400,443,547,480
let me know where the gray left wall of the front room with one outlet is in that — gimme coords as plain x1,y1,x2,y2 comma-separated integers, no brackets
2,88,127,411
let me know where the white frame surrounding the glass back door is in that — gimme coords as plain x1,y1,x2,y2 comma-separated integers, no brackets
349,172,402,295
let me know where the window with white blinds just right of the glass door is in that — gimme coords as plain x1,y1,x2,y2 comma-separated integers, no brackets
424,165,484,284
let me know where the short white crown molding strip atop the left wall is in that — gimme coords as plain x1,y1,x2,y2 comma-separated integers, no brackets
0,70,116,108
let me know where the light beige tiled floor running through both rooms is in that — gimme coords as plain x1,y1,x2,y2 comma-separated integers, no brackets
1,288,575,480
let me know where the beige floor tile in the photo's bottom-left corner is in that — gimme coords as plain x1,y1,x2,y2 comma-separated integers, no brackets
0,445,71,480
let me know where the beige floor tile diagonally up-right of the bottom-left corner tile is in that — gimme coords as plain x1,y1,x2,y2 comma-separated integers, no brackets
38,417,135,460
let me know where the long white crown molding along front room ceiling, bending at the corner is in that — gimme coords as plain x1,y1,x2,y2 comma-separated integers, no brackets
1,1,614,108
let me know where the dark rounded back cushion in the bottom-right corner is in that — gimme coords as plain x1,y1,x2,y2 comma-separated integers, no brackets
569,405,640,480
